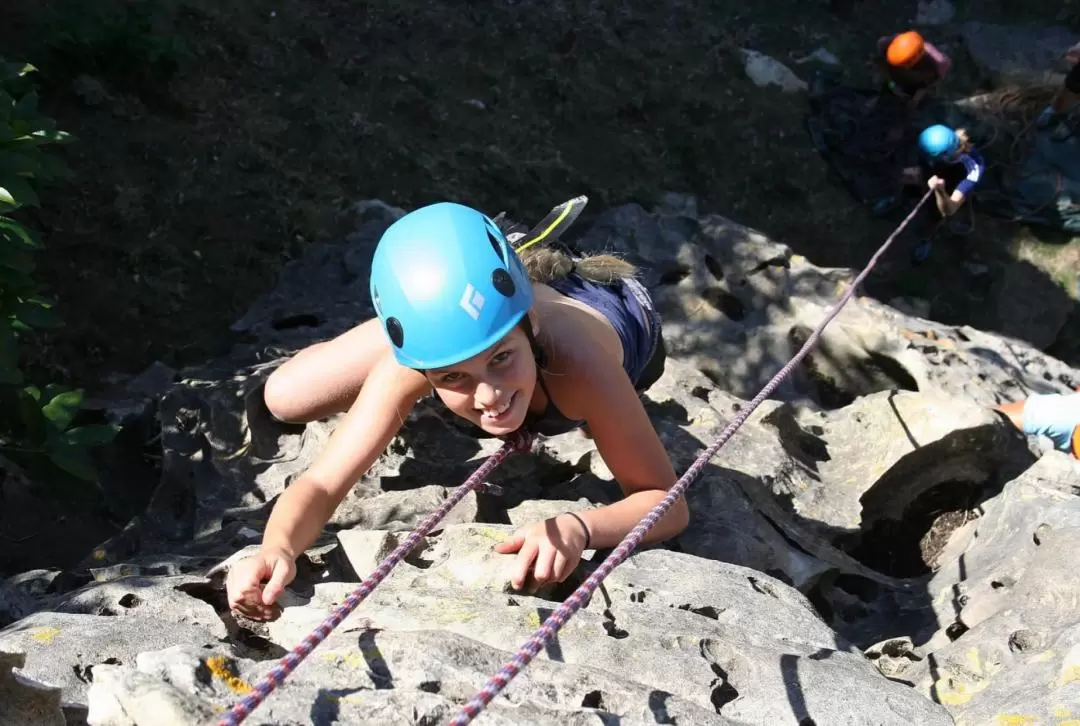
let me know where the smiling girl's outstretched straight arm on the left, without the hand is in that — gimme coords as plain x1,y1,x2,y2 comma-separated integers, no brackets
262,354,430,560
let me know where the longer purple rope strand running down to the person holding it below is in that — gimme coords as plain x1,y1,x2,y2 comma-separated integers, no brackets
449,190,933,726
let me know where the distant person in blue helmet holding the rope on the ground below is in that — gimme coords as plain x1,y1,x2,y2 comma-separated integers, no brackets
904,123,986,264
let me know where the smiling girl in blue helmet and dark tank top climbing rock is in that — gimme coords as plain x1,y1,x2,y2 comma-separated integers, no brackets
227,203,689,619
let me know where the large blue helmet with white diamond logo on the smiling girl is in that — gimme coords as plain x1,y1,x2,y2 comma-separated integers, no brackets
370,202,532,369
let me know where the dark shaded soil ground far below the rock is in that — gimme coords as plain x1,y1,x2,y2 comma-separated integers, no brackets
0,0,1080,564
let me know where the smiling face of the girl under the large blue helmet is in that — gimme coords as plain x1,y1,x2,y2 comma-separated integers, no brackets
427,320,537,436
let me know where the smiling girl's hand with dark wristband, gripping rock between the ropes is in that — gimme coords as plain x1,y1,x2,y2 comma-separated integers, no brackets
495,514,586,594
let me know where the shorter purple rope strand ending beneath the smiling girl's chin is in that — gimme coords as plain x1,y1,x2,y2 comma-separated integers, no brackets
217,432,532,726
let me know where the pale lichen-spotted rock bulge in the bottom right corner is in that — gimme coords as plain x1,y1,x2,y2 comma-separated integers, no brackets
868,452,1080,724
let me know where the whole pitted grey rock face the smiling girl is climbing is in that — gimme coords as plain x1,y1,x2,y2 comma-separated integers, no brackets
0,194,1080,726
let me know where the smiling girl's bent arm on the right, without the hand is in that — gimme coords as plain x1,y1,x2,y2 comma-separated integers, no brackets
564,347,690,548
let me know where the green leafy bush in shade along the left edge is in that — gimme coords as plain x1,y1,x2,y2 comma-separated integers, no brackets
0,61,117,488
